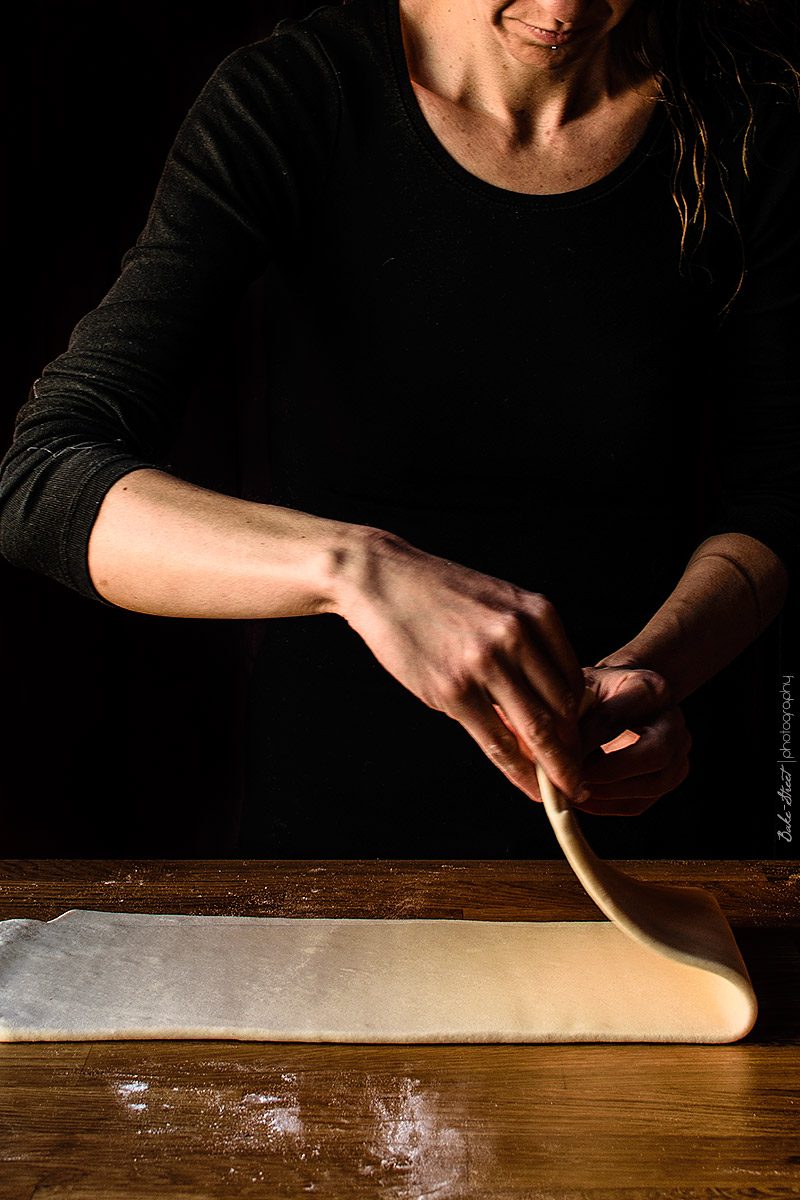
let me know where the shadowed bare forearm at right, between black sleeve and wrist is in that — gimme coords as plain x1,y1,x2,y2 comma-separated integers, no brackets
597,533,788,702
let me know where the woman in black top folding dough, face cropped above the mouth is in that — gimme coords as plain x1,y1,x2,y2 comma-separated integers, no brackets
2,0,799,854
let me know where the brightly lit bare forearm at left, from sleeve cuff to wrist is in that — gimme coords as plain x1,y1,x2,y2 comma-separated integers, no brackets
89,469,368,618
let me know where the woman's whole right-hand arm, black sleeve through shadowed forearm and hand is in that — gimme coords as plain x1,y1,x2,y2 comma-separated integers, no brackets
575,89,800,814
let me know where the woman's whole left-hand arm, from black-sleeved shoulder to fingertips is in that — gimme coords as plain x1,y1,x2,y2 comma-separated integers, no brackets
6,35,583,816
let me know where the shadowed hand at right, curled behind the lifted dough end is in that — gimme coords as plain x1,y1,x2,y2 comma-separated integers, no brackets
581,667,692,816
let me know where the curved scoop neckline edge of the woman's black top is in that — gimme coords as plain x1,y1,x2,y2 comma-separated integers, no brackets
383,0,664,209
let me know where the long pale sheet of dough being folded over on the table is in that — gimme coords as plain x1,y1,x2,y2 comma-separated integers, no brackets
0,788,756,1043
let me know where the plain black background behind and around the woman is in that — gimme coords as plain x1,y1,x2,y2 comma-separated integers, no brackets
0,0,800,857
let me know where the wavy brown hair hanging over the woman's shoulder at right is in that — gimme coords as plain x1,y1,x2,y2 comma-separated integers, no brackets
615,0,800,313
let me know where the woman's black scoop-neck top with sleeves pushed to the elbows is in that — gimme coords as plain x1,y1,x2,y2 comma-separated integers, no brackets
0,0,800,852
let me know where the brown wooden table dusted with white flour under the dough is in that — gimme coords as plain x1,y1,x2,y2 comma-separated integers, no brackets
0,860,800,1200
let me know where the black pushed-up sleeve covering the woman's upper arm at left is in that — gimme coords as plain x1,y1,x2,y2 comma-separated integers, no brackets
0,34,339,598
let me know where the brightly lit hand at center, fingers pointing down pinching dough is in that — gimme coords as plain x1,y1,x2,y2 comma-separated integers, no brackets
337,530,584,800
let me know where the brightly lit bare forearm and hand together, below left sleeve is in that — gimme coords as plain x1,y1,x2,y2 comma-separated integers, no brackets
89,469,583,799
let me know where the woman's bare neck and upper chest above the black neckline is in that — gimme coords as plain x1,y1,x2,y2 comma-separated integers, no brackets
401,0,657,194
